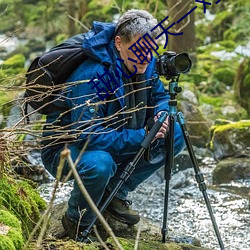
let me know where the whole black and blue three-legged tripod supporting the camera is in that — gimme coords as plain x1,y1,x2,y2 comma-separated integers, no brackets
82,77,225,250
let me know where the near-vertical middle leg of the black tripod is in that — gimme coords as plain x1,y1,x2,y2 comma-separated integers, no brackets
161,114,175,243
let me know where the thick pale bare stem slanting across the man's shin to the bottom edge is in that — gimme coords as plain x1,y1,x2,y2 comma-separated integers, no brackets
61,149,124,250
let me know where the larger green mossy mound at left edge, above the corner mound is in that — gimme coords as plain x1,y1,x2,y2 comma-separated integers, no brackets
0,174,46,238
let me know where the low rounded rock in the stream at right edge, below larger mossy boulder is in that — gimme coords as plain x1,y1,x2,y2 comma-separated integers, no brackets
213,157,250,184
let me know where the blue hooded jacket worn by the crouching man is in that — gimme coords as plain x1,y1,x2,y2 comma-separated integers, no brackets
45,22,169,155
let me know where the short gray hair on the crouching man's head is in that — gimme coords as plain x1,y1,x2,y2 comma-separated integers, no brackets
115,9,159,43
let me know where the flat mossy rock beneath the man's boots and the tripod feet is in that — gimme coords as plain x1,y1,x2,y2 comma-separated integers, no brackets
43,203,209,250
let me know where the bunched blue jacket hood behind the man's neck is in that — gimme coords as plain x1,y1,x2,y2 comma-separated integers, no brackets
82,21,116,65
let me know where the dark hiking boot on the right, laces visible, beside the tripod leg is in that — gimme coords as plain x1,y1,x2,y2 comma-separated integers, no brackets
105,197,140,225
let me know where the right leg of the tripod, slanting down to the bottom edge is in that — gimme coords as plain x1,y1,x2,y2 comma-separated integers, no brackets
177,112,225,250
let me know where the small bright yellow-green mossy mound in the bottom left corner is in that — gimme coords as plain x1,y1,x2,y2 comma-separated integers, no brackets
0,209,24,250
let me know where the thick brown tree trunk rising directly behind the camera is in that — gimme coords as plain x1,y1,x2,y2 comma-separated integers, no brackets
166,0,196,59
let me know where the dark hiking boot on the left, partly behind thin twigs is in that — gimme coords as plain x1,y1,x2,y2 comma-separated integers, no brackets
62,213,97,243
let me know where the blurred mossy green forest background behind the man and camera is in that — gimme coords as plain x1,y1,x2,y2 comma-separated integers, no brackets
0,0,250,127
